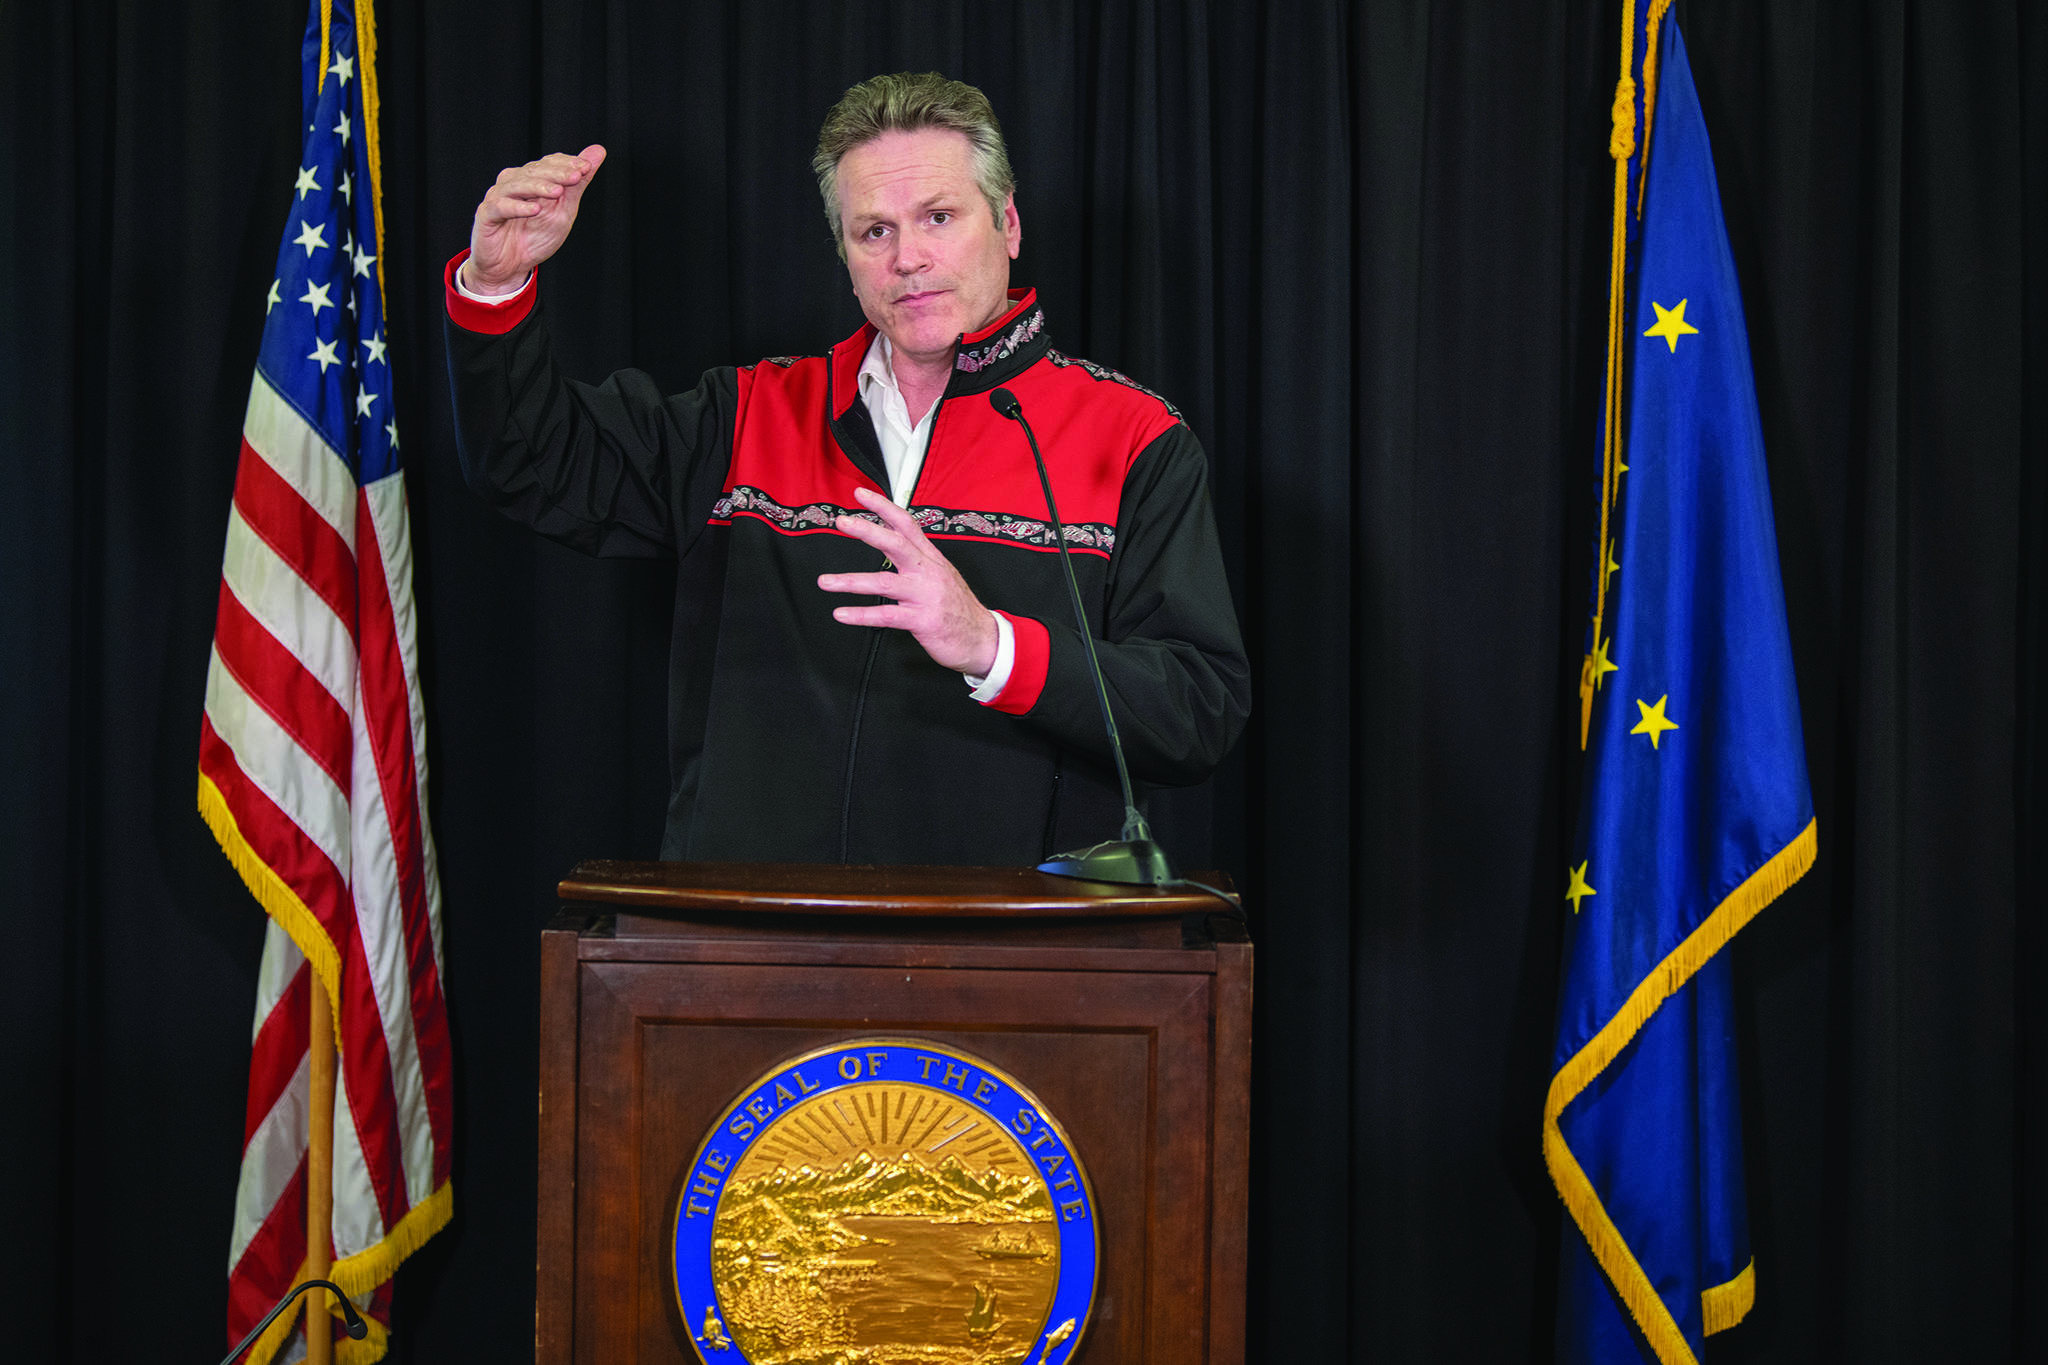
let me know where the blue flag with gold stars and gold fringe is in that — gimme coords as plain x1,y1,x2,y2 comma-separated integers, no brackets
1542,12,1817,1365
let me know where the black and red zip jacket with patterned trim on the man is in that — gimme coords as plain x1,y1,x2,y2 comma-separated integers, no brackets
446,256,1251,866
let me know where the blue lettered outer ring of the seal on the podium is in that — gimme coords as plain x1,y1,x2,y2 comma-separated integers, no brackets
674,1038,1102,1365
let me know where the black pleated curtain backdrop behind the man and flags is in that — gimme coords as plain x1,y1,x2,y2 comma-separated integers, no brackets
0,0,2048,1361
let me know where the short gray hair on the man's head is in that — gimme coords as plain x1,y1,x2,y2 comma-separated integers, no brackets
811,72,1018,260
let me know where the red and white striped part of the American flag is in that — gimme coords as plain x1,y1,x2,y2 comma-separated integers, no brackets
199,372,453,1358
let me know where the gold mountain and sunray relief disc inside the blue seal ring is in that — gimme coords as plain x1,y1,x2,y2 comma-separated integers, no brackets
711,1083,1059,1365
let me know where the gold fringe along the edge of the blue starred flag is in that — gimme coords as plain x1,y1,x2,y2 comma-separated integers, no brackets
1542,821,1819,1365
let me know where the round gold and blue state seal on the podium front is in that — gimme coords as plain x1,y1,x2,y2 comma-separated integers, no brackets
676,1038,1096,1365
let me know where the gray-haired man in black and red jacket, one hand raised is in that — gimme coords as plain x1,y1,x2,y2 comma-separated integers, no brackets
446,74,1249,866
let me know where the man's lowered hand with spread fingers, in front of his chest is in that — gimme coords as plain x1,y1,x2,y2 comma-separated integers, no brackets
817,489,997,677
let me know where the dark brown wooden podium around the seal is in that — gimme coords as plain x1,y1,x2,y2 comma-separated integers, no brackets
535,862,1251,1365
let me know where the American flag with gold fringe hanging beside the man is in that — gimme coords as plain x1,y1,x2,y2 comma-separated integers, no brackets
199,0,453,1365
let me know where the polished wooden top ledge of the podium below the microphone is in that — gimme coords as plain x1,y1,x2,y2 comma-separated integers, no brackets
559,860,1233,919
